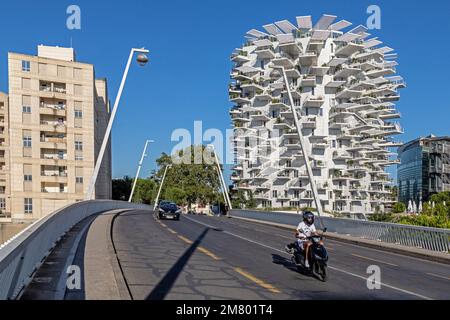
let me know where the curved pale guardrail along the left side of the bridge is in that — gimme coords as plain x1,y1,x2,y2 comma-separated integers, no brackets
0,200,152,300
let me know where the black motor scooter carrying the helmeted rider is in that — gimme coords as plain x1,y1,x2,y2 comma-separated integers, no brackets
292,231,328,282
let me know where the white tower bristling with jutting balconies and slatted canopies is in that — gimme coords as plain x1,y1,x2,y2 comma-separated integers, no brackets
229,15,405,215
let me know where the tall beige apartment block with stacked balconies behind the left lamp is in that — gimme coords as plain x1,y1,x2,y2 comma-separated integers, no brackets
3,46,111,220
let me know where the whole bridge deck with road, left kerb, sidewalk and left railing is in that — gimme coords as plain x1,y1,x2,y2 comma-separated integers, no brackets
0,201,450,300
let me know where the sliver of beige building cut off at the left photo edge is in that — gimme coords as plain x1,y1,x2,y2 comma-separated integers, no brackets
0,92,11,221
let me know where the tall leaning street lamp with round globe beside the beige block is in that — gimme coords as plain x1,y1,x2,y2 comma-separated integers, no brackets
85,48,149,200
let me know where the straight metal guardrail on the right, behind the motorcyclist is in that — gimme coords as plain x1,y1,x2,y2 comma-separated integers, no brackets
229,210,450,253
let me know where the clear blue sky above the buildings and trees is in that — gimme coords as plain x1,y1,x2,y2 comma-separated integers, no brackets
0,0,450,181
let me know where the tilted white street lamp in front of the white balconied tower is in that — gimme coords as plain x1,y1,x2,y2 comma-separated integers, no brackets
271,65,324,227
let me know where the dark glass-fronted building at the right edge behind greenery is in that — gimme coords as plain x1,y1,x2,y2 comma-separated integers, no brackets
397,135,450,205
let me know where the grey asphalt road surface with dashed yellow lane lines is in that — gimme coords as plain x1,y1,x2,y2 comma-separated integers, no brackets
112,211,450,299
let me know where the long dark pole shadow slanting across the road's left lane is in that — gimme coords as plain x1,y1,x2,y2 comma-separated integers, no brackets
145,228,209,300
